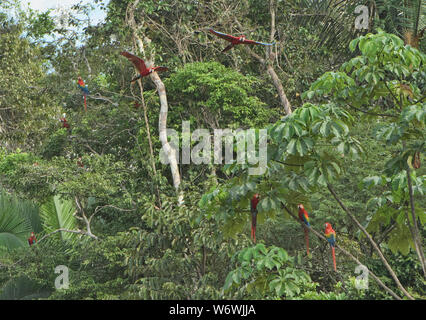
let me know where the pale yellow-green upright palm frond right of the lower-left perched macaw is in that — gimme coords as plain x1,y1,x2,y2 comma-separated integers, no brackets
40,195,77,240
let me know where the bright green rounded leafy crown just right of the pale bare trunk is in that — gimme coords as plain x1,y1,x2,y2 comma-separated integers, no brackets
165,62,276,128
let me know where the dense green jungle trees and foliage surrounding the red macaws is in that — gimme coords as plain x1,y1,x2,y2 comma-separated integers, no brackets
0,0,426,300
